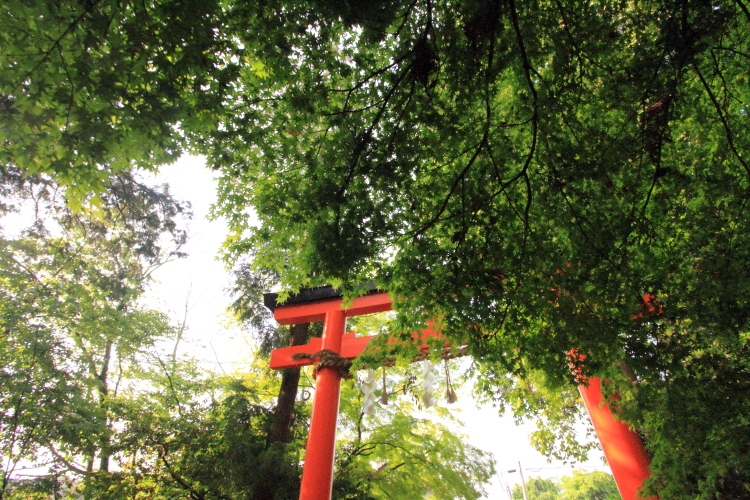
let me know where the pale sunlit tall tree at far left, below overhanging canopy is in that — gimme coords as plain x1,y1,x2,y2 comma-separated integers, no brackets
0,167,191,492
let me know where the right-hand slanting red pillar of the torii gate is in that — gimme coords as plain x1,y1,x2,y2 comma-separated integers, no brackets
578,377,656,500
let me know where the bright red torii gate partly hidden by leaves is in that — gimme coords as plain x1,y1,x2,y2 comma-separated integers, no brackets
264,285,650,500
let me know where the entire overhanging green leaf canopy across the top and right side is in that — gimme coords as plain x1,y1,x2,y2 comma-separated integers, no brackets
0,0,750,498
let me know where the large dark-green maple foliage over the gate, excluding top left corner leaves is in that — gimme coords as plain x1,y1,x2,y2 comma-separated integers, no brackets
201,1,750,498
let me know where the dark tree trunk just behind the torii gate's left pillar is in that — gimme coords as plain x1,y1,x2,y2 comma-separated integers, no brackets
253,323,310,500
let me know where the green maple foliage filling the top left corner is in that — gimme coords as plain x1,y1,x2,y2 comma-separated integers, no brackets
0,1,238,207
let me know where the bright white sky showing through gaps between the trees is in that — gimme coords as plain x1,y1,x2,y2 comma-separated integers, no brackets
147,157,610,500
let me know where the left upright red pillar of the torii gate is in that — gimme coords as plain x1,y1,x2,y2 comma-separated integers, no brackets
299,309,346,500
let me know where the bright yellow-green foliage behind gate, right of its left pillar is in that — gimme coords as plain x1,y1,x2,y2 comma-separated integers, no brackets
334,374,495,500
